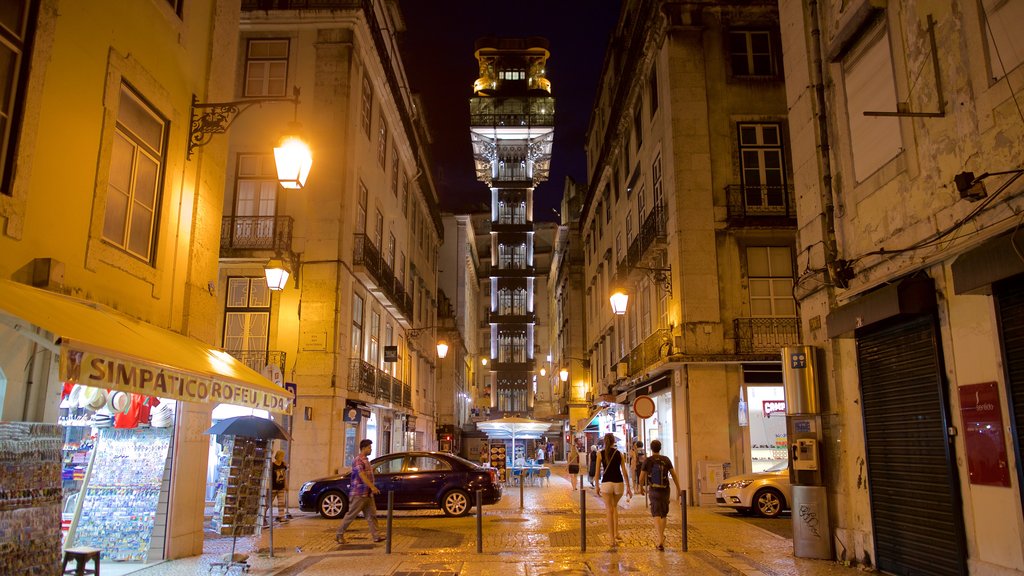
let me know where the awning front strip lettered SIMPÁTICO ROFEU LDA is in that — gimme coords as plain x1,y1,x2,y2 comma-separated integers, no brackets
60,349,292,414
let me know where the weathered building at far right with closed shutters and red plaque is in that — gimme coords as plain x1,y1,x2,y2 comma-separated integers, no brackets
779,1,1024,574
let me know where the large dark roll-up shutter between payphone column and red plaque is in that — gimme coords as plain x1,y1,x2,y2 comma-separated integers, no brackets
857,315,967,576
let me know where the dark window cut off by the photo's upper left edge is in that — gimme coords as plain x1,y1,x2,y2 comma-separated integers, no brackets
0,0,35,195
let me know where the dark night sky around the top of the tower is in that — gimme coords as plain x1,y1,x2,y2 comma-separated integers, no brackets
399,0,620,220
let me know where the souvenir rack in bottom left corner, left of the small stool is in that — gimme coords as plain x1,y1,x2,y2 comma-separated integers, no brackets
0,422,63,576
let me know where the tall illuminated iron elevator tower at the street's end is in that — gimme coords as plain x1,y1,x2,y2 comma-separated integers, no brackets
470,38,555,416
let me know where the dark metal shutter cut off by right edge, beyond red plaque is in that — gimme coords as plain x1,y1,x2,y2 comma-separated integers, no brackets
992,276,1024,516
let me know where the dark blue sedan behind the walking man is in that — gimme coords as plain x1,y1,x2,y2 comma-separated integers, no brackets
299,452,502,519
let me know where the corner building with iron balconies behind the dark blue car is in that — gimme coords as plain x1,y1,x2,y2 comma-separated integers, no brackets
218,0,443,496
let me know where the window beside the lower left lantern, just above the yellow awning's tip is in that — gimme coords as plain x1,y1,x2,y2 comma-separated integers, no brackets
224,277,270,358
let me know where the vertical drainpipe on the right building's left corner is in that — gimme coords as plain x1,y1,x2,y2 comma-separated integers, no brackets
807,0,847,301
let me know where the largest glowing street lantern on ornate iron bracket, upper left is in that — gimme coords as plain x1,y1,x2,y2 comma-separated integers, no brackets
186,86,313,190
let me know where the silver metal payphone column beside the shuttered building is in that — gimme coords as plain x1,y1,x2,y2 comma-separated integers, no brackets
782,346,833,560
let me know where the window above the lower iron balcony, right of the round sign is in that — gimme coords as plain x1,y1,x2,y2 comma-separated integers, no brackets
746,246,797,318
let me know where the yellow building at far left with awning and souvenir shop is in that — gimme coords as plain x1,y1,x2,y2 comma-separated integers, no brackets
0,0,290,561
